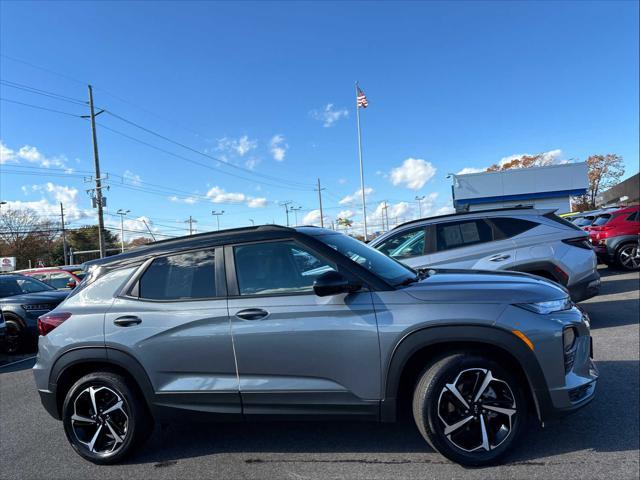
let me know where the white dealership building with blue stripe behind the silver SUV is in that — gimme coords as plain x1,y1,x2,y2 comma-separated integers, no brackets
452,162,589,213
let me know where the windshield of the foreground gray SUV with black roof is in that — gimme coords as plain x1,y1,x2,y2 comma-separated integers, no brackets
316,233,416,286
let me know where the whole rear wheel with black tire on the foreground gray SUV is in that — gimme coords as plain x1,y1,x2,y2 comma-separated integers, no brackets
62,372,153,465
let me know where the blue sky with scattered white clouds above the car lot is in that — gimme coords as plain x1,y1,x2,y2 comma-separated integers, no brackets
0,1,639,236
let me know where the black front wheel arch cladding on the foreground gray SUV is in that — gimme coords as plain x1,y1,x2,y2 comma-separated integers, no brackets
381,325,551,422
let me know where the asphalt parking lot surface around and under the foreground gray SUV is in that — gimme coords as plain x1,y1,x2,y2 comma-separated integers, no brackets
0,269,640,479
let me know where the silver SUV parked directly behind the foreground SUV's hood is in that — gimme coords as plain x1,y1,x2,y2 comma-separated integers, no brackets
370,207,600,302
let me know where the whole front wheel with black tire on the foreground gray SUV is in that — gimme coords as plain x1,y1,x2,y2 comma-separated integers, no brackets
413,353,528,467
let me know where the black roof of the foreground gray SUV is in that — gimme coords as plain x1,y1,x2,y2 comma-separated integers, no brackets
83,225,296,268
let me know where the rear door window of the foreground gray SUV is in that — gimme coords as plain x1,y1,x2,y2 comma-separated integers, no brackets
138,250,216,300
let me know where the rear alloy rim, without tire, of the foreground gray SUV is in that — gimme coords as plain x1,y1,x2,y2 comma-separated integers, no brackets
71,386,129,456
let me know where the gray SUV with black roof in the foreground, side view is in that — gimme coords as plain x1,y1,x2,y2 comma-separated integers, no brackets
33,226,598,465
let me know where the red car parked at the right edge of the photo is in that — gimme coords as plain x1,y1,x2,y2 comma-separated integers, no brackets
589,205,640,270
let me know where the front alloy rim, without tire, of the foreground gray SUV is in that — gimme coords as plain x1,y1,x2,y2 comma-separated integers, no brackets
438,368,517,452
